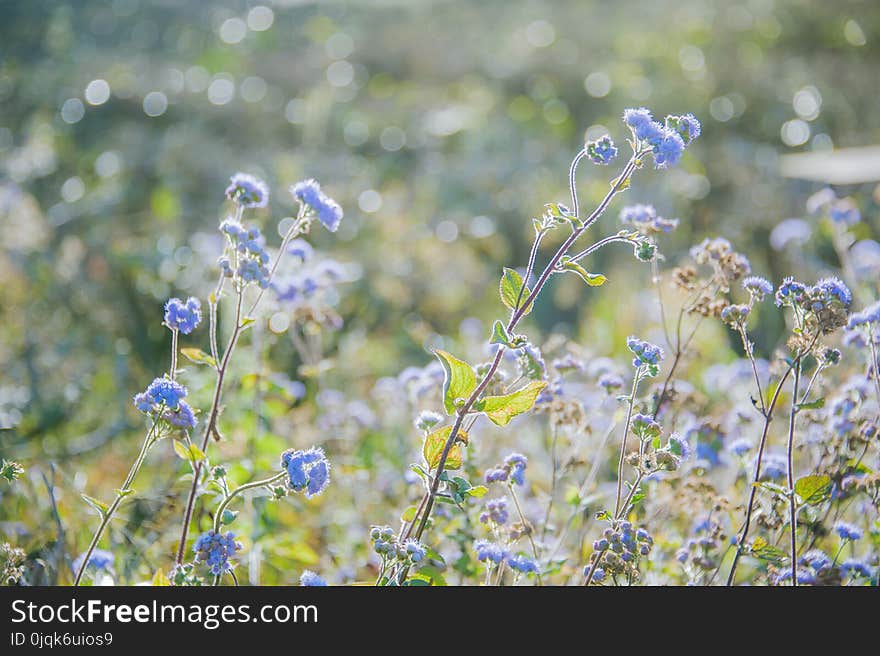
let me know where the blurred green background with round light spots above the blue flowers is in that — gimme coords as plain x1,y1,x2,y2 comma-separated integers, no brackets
0,0,880,581
